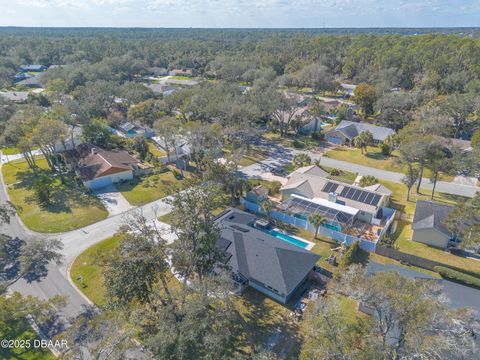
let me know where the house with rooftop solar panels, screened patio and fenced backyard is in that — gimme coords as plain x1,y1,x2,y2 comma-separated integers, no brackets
245,166,395,251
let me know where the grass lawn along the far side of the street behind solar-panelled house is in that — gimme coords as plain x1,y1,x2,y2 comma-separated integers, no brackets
324,146,453,181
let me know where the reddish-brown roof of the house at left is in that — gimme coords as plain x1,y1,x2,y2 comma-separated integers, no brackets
71,144,140,181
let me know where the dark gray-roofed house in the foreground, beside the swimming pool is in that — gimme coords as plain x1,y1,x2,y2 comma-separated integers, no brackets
216,209,320,304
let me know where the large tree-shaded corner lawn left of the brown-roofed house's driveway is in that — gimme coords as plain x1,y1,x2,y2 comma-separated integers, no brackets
2,159,108,233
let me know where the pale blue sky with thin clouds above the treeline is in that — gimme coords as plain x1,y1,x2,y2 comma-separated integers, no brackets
0,0,480,28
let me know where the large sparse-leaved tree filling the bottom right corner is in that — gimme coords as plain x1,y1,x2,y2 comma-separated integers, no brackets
308,265,480,360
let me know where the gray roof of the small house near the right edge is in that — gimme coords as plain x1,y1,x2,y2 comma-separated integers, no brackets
412,200,453,236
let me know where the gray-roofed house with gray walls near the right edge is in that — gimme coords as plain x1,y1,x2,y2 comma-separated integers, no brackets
412,200,454,249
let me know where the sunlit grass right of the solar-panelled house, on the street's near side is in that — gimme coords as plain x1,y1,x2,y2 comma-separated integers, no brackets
379,180,467,220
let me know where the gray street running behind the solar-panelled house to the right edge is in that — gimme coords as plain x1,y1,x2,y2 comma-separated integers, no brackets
241,146,480,197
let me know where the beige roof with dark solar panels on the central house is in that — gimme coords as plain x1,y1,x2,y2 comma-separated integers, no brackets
280,165,389,213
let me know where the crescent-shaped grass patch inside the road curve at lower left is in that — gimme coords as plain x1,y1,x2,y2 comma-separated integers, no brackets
70,234,122,306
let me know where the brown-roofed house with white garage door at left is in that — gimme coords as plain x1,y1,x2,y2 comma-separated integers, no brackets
65,144,152,190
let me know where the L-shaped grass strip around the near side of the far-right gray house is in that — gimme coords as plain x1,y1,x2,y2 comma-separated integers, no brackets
394,221,480,272
